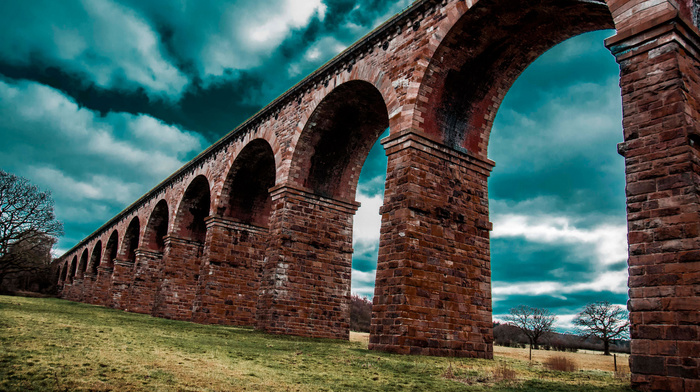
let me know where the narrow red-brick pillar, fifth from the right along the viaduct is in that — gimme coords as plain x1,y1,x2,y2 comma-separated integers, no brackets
153,236,203,321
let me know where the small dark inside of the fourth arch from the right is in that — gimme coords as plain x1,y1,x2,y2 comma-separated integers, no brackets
174,175,211,243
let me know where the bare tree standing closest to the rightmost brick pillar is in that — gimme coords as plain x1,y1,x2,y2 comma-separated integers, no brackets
574,301,630,355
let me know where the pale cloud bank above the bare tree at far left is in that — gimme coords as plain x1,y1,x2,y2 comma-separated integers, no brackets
0,80,205,236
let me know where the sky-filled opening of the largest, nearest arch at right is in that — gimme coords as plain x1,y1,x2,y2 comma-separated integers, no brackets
488,30,629,340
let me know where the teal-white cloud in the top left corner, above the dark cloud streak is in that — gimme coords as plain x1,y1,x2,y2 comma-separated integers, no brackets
0,0,189,98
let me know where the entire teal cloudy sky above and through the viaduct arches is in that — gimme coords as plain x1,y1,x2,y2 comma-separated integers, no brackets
0,0,627,329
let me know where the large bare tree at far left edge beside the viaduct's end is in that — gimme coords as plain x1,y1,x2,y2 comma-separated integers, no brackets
0,170,63,283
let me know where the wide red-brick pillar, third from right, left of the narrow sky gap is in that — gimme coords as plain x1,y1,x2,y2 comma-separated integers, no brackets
257,186,359,339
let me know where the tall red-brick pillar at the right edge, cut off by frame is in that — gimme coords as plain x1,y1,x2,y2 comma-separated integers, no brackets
606,11,700,391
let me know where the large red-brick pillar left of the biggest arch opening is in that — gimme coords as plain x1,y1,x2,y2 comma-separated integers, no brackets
369,129,494,358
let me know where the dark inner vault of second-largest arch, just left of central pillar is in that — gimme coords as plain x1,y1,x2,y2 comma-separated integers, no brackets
292,80,389,201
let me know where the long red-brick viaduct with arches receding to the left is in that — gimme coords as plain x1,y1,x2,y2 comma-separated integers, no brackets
57,0,700,391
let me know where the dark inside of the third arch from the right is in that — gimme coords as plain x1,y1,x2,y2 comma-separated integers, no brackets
218,139,276,227
